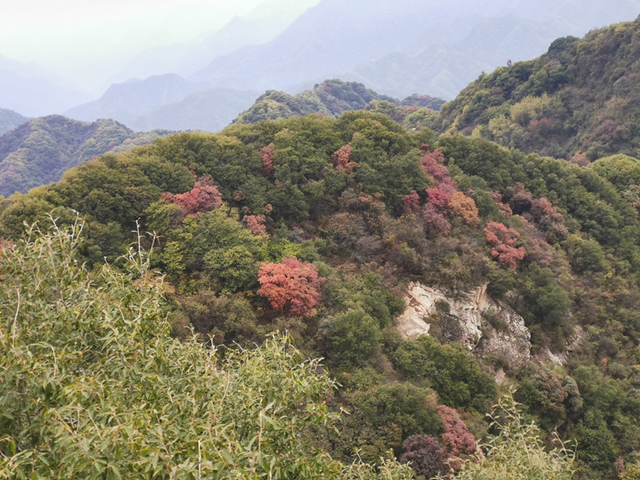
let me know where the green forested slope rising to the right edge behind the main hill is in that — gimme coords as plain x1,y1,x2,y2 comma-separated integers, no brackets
433,18,640,160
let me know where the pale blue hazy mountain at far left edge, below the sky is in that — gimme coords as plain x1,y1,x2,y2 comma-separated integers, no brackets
0,55,89,117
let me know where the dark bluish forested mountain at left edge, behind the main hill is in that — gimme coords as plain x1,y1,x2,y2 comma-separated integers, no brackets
0,115,168,196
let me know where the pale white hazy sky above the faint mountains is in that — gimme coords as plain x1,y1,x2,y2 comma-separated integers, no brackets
0,0,265,89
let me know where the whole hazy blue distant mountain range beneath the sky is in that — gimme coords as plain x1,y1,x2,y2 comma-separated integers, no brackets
0,0,640,139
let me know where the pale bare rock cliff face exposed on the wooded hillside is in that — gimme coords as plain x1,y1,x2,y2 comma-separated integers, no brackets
396,283,531,368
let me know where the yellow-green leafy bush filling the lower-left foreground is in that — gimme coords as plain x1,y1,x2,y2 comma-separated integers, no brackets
0,219,411,480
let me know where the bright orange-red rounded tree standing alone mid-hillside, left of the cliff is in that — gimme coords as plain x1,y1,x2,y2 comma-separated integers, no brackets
258,258,324,317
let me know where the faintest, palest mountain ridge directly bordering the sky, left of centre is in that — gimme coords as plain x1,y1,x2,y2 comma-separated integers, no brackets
116,0,319,79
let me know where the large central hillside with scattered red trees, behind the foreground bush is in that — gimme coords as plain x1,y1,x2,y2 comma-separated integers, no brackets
0,107,640,479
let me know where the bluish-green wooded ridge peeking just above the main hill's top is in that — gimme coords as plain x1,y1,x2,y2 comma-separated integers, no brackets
234,80,444,124
